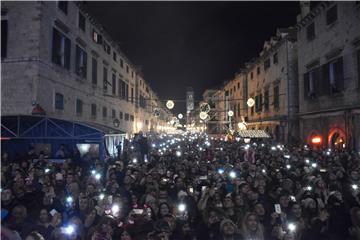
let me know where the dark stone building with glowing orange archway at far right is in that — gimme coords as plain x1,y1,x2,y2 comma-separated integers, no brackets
296,2,360,150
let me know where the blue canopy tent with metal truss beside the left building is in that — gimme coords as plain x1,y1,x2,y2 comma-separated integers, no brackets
1,115,125,159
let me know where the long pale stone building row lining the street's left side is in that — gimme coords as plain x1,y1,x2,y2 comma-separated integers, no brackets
1,1,169,137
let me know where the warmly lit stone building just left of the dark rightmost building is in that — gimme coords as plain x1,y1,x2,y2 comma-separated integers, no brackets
243,28,298,142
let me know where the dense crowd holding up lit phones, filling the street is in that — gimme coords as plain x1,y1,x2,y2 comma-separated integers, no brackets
1,133,360,240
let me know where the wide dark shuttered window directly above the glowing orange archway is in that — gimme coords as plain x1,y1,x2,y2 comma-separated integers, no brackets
320,57,344,94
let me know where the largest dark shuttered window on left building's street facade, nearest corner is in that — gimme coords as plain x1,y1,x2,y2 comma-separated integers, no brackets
52,28,70,69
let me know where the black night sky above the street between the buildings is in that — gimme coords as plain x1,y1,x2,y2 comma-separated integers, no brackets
86,1,299,112
